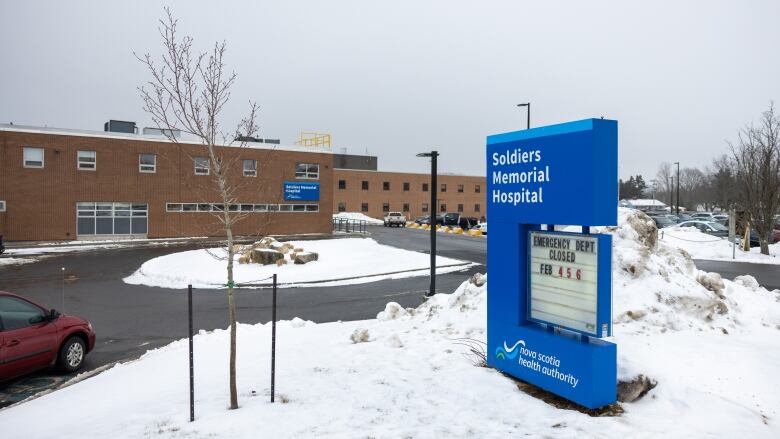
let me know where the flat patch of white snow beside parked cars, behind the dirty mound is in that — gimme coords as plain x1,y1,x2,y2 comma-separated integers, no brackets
658,226,780,264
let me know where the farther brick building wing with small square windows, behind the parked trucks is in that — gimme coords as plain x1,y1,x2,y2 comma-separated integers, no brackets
333,168,487,219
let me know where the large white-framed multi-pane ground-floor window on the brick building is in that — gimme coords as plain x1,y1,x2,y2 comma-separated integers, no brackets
76,202,149,236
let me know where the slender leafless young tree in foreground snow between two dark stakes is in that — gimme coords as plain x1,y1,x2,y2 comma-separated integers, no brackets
136,8,258,409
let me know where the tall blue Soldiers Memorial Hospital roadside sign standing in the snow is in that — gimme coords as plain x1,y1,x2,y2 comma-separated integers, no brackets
486,119,617,408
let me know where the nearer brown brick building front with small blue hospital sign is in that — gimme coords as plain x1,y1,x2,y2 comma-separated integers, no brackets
0,125,334,241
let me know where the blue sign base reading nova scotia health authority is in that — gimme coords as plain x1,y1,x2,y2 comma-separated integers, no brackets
487,323,617,409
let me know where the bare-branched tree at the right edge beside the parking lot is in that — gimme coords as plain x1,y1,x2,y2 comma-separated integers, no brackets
730,104,780,255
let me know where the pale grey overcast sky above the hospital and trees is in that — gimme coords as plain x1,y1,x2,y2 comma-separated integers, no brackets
0,0,780,180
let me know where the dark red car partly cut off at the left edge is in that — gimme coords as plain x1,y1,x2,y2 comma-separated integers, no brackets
0,291,95,381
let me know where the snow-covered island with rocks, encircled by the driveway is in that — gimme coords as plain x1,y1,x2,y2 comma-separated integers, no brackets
124,238,473,289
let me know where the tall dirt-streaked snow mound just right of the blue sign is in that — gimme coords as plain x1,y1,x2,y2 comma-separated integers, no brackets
600,209,780,332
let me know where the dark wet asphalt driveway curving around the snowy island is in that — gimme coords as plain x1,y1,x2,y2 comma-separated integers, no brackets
0,226,486,407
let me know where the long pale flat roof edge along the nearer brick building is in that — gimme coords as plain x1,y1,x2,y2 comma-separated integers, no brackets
0,123,333,155
